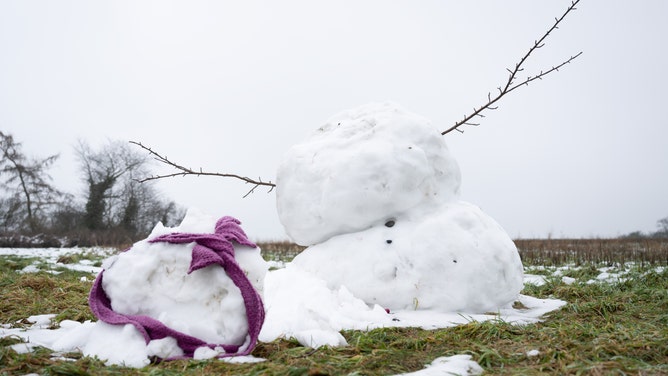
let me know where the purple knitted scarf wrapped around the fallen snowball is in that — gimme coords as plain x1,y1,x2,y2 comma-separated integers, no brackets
88,217,264,360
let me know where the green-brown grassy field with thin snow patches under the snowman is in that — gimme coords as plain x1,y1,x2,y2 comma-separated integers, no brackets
0,239,668,375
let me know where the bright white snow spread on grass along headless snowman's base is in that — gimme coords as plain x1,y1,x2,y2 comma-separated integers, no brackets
260,265,566,348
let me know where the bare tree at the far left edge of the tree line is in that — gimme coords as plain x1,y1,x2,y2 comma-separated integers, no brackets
0,132,61,232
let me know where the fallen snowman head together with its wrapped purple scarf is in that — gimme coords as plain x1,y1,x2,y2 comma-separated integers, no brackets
83,209,268,367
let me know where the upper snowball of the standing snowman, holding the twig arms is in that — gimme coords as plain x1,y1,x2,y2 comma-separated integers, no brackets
276,103,460,245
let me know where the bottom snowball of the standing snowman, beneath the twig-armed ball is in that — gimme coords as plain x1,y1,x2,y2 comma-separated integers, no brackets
292,201,523,312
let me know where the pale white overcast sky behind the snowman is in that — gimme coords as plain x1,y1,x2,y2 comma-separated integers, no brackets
0,0,668,240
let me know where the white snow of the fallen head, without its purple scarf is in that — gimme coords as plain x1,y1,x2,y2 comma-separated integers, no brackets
102,210,268,345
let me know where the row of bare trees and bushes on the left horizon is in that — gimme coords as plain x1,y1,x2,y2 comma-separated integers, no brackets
0,131,184,246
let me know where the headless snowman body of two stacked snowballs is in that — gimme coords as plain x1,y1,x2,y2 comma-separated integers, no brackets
277,103,523,313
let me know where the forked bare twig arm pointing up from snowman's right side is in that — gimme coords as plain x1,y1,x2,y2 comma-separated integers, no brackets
441,0,582,135
